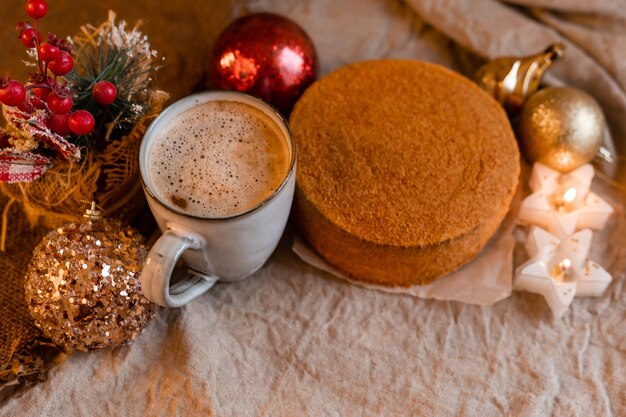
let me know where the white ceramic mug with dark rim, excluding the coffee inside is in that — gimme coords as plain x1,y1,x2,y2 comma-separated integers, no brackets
139,91,296,307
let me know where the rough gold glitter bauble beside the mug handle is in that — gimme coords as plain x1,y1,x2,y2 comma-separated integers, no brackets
25,220,156,351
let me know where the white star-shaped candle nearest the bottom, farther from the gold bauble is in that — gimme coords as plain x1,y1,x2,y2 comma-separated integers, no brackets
513,226,612,318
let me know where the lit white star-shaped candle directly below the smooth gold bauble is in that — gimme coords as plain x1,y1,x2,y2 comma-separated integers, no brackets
519,163,613,239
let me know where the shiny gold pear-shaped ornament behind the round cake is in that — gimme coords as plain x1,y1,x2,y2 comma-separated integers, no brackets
475,42,565,115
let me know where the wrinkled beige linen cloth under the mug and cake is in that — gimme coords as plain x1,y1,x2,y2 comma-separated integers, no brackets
0,0,626,417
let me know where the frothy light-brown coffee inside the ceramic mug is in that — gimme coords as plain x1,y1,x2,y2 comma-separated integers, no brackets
148,101,291,217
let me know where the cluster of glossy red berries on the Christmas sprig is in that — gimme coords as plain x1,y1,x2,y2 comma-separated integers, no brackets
0,0,117,136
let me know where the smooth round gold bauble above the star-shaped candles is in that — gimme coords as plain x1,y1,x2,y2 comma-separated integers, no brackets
518,87,606,172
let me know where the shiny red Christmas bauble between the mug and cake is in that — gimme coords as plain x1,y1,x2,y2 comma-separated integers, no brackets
209,13,317,114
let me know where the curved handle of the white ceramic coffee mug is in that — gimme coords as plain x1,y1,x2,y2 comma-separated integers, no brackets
140,229,218,307
